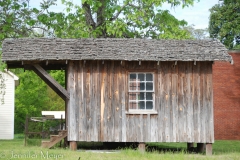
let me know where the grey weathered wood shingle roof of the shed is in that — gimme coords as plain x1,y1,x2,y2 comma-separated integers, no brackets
2,38,232,62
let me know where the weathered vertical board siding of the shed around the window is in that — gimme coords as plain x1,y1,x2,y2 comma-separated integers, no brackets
67,61,214,143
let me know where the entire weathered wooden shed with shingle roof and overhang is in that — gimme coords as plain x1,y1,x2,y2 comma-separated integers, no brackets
2,38,232,153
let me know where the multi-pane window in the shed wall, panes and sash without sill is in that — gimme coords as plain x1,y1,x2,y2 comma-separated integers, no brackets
128,72,154,111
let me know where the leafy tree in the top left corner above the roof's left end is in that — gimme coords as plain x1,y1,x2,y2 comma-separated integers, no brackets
0,0,54,45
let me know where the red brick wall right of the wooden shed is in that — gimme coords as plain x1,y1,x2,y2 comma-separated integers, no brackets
213,51,240,140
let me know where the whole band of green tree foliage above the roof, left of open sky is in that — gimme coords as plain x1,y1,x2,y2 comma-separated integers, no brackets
0,0,197,42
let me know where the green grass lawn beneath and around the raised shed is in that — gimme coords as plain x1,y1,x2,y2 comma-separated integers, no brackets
0,135,240,160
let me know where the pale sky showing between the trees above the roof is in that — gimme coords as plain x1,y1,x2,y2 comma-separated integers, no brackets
30,0,219,29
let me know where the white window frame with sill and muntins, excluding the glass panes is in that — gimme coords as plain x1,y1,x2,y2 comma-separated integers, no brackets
127,72,157,114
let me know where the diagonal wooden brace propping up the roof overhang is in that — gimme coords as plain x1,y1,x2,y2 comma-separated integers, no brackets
32,64,70,100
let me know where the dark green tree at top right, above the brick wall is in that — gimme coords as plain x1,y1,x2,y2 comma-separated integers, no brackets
209,0,240,49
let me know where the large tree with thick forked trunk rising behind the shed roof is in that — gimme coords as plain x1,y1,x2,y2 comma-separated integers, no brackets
35,0,199,39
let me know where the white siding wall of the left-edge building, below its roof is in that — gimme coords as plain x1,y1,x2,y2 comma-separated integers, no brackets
0,72,15,139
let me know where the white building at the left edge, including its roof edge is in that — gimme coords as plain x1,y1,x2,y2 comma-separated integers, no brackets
0,71,19,139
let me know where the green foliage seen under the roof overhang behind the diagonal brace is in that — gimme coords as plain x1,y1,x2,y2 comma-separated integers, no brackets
15,69,65,133
